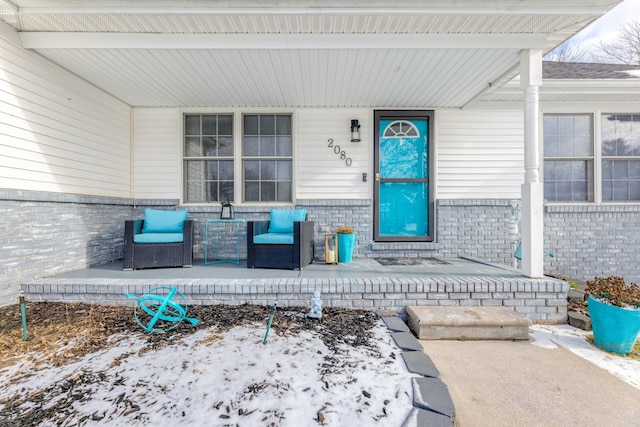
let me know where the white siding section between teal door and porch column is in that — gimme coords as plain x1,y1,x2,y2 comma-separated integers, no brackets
436,110,524,199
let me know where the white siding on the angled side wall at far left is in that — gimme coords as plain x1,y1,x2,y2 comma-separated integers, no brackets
0,42,131,197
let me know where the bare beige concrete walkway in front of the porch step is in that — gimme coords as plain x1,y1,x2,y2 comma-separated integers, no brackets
420,340,640,427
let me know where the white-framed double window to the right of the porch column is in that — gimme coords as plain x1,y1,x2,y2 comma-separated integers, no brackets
543,112,640,203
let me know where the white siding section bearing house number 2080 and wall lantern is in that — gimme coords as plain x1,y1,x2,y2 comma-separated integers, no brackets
294,108,373,199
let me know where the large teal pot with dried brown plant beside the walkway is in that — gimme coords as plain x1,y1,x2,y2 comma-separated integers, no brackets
586,276,640,354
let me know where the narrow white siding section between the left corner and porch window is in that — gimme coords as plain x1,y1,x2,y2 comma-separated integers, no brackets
133,108,182,199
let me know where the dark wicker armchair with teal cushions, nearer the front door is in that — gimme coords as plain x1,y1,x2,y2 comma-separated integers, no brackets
247,209,314,270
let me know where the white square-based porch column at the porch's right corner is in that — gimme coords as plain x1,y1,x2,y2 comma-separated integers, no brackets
520,50,544,277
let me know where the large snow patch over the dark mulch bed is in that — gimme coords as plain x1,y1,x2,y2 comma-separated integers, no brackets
0,324,415,427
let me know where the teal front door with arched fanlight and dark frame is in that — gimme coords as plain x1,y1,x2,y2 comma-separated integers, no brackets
374,111,433,241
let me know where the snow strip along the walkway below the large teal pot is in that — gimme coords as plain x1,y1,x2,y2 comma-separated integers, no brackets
529,325,640,389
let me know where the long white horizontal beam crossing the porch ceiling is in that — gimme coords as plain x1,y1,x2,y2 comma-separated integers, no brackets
20,32,547,49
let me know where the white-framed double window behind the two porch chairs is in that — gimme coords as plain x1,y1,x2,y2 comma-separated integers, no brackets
183,113,293,203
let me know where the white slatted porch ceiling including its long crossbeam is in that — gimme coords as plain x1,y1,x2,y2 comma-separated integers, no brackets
0,0,619,108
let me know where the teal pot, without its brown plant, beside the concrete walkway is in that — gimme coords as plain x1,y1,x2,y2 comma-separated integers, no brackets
589,296,640,354
